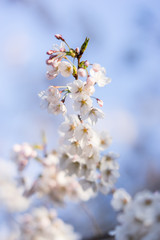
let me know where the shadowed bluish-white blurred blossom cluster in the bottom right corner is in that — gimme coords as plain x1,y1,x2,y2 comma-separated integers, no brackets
116,191,160,240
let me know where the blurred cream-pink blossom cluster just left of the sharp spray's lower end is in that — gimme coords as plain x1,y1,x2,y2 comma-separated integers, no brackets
34,154,93,202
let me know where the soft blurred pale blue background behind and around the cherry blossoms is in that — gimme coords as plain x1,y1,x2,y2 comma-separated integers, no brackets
0,0,160,236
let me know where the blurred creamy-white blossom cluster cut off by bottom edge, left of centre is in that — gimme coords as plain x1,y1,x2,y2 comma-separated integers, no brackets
7,207,80,240
